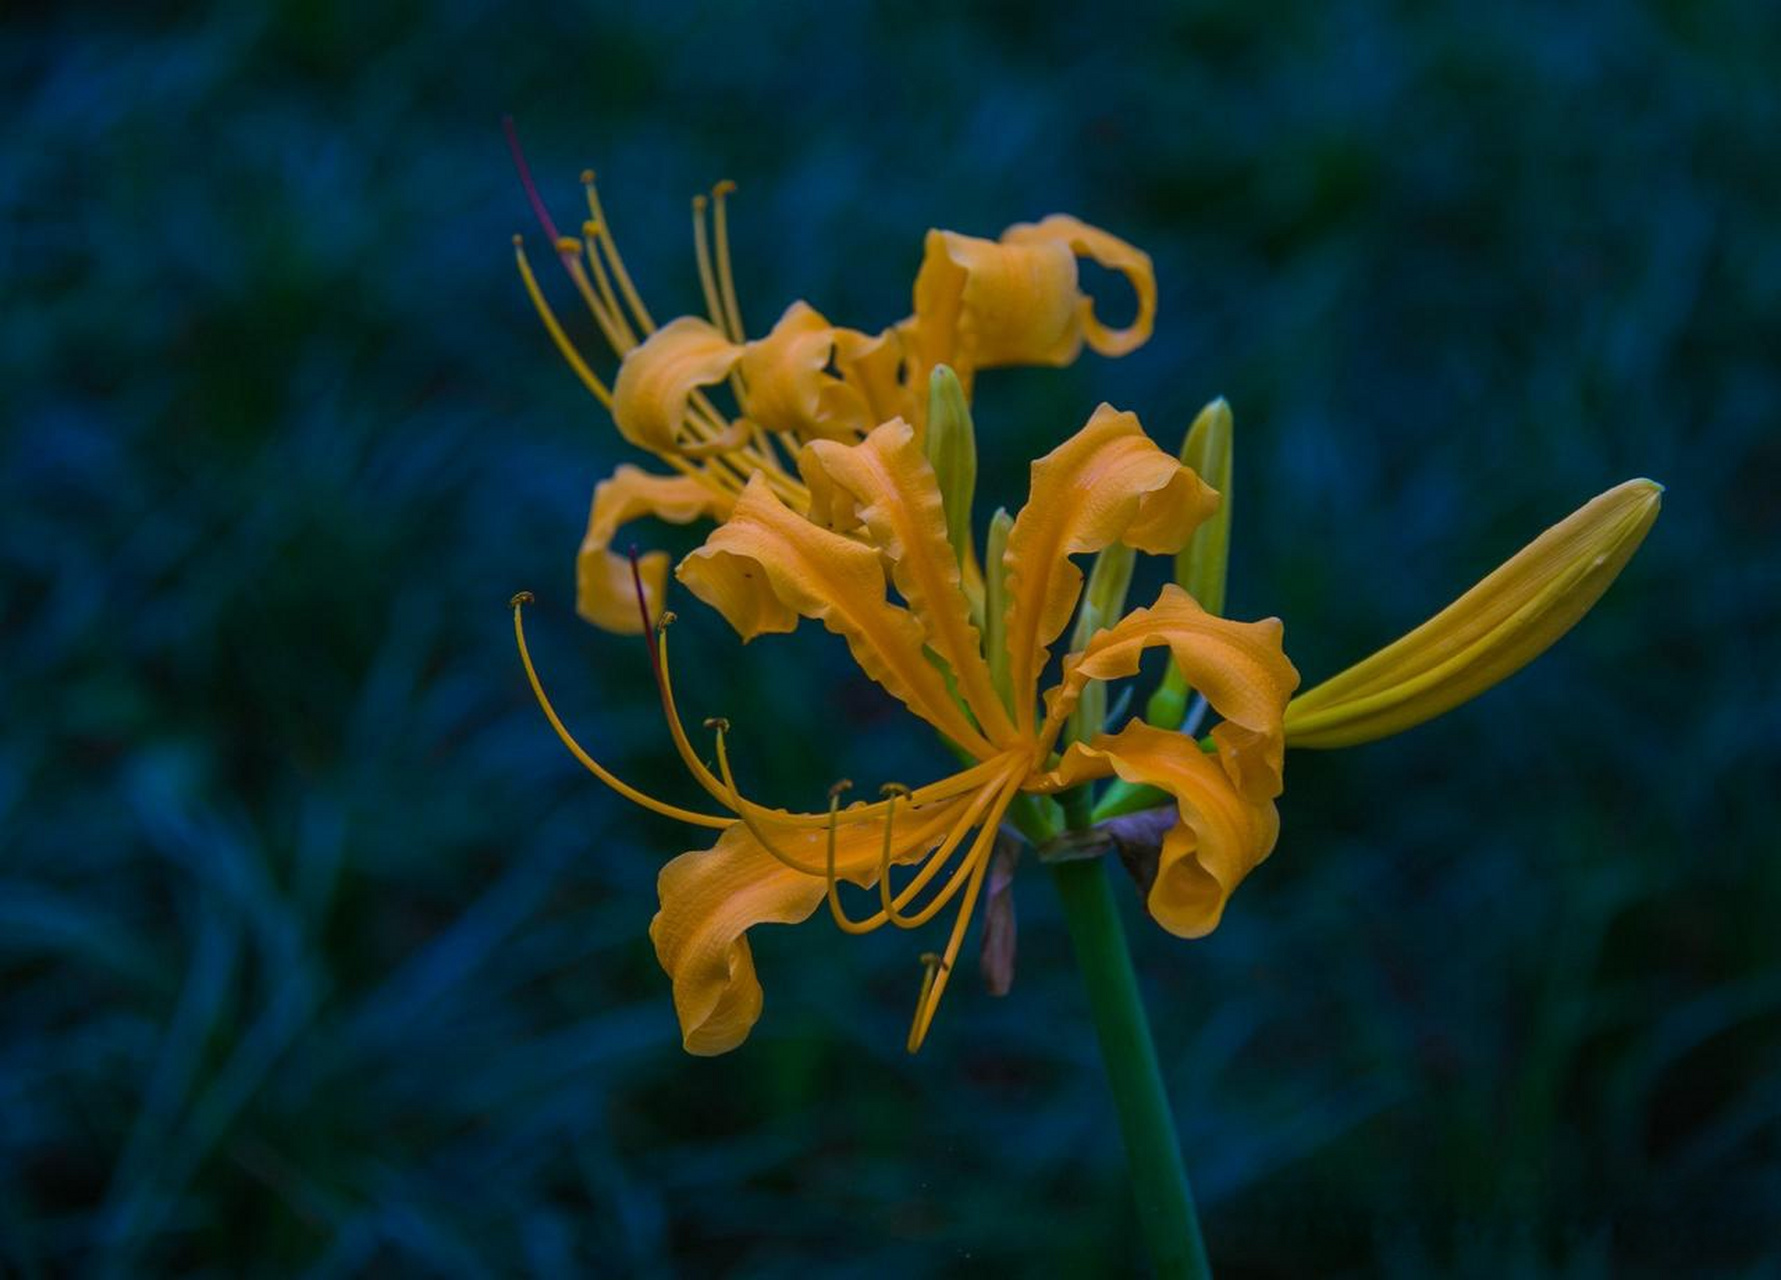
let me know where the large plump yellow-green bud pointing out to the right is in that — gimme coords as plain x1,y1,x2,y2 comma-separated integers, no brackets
1286,481,1663,746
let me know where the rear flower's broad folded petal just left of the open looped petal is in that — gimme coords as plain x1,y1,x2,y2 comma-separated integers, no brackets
914,231,1083,375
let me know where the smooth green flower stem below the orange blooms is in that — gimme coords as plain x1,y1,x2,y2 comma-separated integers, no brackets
1051,829,1211,1280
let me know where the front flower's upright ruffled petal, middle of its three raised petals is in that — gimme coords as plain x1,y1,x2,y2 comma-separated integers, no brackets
798,418,1013,744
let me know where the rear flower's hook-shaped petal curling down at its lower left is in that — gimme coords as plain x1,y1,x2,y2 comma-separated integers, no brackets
575,463,730,636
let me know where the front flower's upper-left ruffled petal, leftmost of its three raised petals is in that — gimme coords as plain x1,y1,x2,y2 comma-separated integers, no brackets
675,474,994,760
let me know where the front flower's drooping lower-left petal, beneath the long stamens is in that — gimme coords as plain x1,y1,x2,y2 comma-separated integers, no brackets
650,792,974,1056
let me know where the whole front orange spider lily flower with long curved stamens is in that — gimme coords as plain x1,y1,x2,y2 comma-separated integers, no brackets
515,406,1298,1054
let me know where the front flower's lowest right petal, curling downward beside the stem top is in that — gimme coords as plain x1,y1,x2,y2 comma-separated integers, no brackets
1053,721,1281,938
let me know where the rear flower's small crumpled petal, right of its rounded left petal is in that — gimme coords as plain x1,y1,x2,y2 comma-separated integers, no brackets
741,303,874,440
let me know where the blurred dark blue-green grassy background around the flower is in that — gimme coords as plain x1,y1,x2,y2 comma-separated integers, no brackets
0,0,1781,1276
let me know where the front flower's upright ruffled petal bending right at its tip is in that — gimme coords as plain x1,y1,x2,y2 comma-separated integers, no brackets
1003,404,1218,728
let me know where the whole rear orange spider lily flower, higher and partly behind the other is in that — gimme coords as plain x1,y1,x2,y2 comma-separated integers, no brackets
509,125,1156,632
